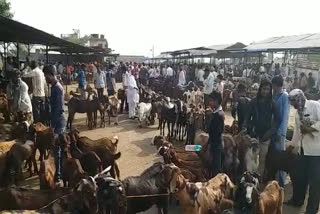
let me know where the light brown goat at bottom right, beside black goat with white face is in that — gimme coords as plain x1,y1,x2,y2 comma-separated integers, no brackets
256,181,284,214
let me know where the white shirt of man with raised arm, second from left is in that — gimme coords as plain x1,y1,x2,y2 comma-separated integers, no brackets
23,67,48,97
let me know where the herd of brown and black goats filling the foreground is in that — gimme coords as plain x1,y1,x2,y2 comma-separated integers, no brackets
0,118,295,214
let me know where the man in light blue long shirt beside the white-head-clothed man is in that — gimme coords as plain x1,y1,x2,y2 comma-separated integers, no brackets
271,75,290,187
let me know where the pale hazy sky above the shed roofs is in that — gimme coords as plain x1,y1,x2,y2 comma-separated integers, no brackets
9,0,320,57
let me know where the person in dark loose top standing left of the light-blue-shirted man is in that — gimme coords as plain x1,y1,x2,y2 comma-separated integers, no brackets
244,80,280,175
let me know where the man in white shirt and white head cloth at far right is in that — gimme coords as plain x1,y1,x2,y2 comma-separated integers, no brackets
288,89,320,214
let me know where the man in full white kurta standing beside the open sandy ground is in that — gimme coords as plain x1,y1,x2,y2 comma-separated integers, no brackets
127,74,139,119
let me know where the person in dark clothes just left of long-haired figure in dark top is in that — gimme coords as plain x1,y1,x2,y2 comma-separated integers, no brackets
231,83,251,130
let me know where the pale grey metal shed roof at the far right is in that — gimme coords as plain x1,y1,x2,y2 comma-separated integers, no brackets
245,33,320,52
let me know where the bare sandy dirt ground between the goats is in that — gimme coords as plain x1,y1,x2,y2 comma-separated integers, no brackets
18,84,314,214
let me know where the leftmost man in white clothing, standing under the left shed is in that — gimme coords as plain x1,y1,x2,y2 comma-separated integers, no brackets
7,68,33,124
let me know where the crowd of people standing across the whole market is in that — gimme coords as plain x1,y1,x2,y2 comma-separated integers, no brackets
1,56,320,214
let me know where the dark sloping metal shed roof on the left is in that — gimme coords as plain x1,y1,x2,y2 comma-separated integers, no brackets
0,16,91,52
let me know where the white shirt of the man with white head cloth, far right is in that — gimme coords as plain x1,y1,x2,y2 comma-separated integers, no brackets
288,100,320,155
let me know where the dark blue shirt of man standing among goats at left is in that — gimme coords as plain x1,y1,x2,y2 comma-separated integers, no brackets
50,82,64,127
